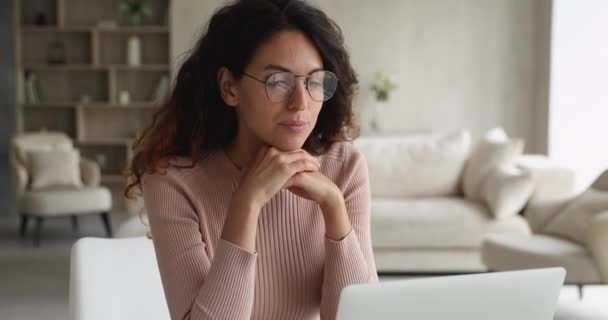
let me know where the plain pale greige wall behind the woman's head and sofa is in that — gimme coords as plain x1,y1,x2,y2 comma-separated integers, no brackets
172,0,547,151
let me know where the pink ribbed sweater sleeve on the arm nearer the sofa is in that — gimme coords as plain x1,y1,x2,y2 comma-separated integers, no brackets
321,149,378,320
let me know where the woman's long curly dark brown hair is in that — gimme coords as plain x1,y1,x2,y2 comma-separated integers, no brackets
124,0,359,197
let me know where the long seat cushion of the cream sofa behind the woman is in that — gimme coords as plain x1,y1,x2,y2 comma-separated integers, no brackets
371,197,529,249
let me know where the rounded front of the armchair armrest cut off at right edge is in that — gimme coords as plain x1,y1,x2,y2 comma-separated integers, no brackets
585,211,608,284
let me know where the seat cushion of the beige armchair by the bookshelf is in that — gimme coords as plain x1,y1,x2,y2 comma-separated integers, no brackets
19,187,112,216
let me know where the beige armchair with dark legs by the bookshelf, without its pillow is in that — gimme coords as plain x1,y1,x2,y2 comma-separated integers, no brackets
10,131,112,247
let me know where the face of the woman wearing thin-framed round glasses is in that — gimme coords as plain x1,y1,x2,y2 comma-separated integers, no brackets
222,31,323,151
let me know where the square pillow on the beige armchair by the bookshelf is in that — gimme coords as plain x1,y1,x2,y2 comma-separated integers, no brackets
27,149,82,190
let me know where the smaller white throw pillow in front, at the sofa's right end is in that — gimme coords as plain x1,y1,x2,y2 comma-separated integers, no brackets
481,163,534,219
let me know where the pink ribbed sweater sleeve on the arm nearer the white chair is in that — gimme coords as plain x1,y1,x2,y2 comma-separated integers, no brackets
142,170,257,320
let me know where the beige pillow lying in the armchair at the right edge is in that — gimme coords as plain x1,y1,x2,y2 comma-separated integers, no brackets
543,171,608,245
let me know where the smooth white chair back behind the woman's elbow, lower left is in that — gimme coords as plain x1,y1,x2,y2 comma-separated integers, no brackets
70,237,170,320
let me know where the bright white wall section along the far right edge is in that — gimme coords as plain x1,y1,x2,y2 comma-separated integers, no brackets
549,0,608,189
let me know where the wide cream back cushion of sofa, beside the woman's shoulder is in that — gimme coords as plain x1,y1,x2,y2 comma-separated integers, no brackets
354,131,471,197
